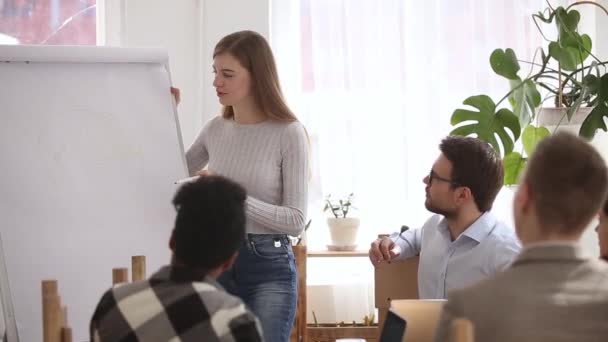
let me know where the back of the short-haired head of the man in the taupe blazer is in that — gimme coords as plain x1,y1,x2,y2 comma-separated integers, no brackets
523,132,608,234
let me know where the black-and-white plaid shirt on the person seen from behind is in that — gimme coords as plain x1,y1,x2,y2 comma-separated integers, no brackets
90,266,263,342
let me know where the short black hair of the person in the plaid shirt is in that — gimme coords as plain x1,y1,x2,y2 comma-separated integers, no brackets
172,176,247,270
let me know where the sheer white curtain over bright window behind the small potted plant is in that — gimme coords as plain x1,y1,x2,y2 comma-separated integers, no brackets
270,0,580,320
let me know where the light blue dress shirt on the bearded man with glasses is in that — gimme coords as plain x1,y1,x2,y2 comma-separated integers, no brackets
390,212,521,299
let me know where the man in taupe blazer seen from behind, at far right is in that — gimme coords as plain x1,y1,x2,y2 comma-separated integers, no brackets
435,133,608,342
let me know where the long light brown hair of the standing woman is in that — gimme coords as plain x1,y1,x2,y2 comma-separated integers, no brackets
213,31,298,122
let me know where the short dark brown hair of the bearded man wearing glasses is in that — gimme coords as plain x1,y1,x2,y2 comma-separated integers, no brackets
439,136,504,212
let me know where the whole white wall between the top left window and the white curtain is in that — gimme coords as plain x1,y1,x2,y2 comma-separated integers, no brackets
98,0,270,147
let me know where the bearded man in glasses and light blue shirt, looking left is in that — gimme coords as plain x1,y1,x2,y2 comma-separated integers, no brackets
369,136,521,299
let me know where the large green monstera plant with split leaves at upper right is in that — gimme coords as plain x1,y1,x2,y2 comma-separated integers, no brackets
450,1,608,185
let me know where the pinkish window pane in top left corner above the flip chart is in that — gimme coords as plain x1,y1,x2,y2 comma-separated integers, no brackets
0,0,96,45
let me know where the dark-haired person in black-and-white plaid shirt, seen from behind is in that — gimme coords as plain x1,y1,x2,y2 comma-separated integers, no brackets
90,176,262,342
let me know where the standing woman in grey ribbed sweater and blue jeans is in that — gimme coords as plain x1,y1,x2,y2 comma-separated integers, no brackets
176,31,308,342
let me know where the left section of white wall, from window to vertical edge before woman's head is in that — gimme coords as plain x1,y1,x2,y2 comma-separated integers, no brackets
100,0,202,146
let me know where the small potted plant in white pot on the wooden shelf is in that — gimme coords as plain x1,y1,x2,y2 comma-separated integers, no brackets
323,193,360,251
